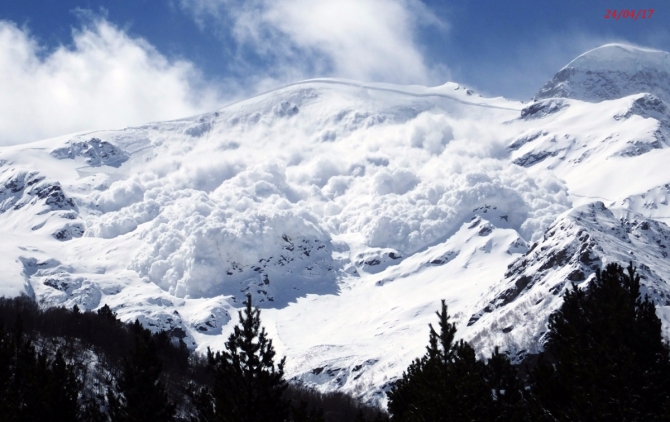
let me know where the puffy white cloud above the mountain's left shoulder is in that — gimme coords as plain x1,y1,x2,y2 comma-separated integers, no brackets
0,18,223,145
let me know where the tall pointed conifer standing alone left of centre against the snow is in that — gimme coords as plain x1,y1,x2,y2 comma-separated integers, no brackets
193,295,289,422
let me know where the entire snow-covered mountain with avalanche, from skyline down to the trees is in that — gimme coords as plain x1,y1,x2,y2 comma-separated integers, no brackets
0,45,670,401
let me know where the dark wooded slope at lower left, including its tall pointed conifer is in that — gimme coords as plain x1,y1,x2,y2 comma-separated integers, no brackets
0,297,388,422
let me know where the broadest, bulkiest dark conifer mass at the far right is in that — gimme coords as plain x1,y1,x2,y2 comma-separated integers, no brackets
532,263,670,421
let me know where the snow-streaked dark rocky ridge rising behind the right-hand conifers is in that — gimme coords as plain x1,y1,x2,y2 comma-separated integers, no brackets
467,202,670,357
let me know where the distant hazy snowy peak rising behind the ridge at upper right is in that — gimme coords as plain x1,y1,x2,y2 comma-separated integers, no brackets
535,44,670,102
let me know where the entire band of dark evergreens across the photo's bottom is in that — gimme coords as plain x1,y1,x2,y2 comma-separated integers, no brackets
0,264,670,422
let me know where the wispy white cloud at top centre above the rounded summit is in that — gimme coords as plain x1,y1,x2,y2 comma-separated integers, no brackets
181,0,446,85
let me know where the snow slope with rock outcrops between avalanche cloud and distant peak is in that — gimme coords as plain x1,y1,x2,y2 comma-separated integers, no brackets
508,94,670,218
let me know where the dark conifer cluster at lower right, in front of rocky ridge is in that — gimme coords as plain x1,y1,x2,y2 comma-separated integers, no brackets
388,264,670,422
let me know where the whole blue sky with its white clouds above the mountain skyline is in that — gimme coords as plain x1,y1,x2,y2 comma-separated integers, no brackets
0,0,670,144
